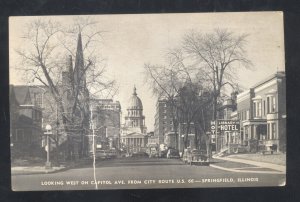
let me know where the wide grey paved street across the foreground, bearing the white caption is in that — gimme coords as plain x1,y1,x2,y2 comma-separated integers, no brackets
12,158,285,191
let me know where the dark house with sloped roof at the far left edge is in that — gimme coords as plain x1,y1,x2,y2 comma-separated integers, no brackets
9,85,43,158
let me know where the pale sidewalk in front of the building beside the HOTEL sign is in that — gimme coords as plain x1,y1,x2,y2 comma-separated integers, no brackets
213,155,286,173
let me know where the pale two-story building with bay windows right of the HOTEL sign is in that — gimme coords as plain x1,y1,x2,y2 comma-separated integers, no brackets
237,72,286,151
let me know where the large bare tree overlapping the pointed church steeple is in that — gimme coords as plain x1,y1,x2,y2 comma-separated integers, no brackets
16,18,116,159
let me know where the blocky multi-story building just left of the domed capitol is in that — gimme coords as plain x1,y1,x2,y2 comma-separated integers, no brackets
89,99,121,150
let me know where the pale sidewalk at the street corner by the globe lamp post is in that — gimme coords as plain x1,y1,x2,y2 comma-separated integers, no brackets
11,159,90,175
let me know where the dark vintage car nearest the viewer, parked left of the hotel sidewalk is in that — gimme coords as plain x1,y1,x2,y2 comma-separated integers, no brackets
182,149,209,166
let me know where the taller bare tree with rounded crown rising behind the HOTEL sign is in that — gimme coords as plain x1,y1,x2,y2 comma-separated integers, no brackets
183,29,252,119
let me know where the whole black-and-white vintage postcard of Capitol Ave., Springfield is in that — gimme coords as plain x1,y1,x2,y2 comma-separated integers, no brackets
9,12,286,191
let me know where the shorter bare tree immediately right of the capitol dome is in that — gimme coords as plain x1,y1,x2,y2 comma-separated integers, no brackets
145,49,209,152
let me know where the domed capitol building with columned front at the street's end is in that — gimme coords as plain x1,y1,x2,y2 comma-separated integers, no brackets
121,87,147,153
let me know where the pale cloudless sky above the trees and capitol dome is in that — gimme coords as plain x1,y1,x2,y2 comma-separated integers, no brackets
9,12,285,131
